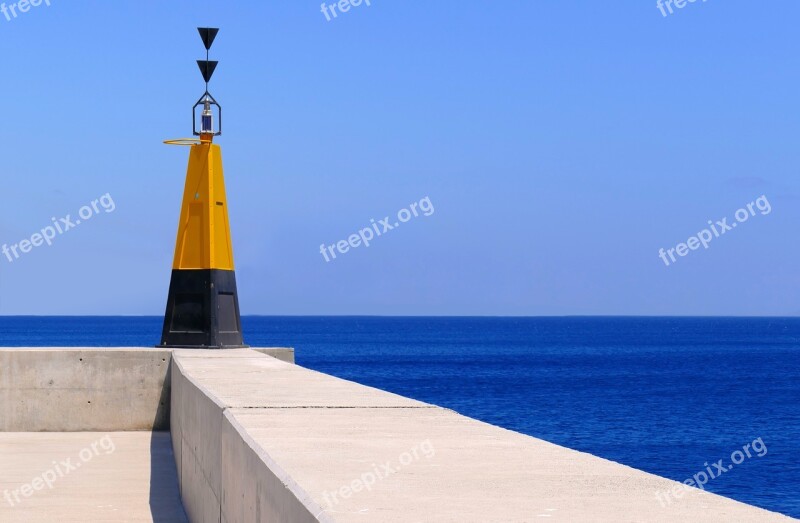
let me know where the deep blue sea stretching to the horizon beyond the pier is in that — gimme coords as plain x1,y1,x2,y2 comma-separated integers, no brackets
0,317,800,517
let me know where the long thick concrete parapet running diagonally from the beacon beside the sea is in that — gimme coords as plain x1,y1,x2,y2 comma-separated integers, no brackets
172,350,792,523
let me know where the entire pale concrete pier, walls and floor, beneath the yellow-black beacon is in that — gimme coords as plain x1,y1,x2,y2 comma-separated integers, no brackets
0,349,792,523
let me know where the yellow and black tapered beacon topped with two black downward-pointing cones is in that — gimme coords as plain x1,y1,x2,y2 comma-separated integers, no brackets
160,27,246,349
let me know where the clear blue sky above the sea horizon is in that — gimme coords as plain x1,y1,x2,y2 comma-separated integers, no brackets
0,0,800,315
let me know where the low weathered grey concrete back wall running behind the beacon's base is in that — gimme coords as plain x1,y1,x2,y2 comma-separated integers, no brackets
0,347,294,432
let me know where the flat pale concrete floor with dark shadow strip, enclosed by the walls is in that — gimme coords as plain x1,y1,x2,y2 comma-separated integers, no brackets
0,432,188,523
